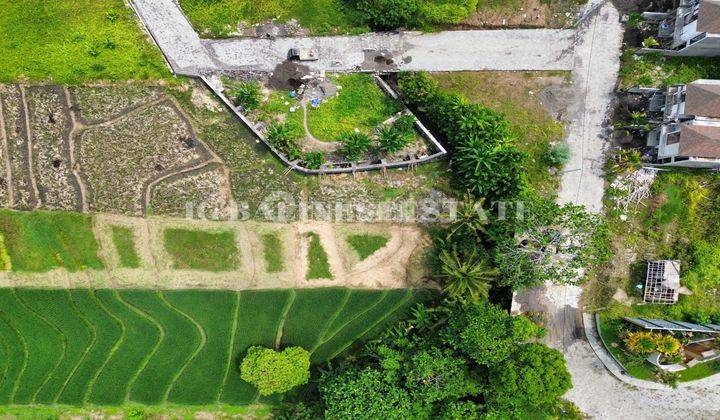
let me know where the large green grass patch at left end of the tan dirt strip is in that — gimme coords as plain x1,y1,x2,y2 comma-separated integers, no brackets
0,210,103,272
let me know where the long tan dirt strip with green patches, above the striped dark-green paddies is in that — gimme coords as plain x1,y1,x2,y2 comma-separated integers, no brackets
0,211,429,290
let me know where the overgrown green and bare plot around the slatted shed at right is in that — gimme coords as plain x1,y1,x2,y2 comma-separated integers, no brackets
583,170,720,381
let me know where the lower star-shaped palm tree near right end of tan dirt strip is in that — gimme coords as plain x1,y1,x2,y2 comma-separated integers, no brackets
440,249,498,301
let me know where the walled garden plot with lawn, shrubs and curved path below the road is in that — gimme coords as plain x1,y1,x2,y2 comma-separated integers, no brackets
225,73,433,169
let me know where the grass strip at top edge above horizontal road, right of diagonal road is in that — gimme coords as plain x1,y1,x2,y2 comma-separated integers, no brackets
180,0,362,37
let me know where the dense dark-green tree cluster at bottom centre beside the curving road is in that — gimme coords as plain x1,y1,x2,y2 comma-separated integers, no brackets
276,303,571,419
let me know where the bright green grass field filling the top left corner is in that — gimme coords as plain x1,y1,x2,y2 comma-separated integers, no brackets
0,0,171,84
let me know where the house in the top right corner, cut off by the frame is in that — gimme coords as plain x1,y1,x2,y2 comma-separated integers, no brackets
641,0,720,57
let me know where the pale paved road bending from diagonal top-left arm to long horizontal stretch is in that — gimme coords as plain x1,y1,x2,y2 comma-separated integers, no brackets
132,0,574,75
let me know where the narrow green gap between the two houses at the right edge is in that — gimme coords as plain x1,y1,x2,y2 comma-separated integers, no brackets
620,49,720,89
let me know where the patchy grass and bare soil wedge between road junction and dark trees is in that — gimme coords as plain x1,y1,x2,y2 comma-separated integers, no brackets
432,71,570,195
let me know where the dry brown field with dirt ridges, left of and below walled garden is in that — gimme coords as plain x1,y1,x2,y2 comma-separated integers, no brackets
0,81,450,219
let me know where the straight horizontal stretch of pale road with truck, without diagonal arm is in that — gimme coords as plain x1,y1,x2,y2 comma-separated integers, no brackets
203,29,574,71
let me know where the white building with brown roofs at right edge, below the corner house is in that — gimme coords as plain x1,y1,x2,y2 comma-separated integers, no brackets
647,80,720,169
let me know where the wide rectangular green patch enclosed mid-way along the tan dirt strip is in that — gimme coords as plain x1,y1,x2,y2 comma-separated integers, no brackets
164,229,239,271
